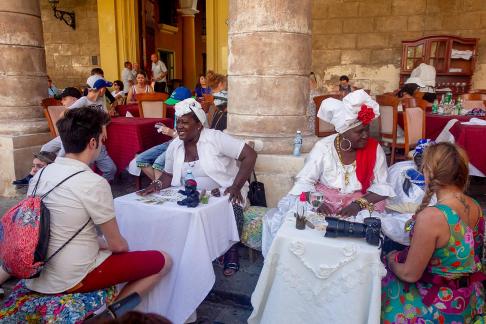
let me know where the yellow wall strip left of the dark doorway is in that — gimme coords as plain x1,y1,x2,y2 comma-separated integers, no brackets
98,0,139,81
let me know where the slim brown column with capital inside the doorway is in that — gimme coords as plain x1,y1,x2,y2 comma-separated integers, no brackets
178,5,199,89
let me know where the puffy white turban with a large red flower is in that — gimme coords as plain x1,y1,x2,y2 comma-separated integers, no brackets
317,90,380,134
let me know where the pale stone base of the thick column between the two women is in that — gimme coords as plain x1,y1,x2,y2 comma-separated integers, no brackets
255,154,305,207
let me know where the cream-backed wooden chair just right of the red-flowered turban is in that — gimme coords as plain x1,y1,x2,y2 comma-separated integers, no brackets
376,95,405,164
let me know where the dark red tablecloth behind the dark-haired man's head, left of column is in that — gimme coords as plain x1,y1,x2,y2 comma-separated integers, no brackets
106,117,174,172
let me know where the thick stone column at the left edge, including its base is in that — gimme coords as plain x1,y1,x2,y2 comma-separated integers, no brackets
0,0,50,196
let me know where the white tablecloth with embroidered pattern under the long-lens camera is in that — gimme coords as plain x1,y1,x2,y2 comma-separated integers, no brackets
248,218,386,324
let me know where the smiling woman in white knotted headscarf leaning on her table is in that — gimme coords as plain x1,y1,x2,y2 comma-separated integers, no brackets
139,98,257,276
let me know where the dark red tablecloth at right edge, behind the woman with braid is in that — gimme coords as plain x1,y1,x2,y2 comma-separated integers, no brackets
450,123,486,174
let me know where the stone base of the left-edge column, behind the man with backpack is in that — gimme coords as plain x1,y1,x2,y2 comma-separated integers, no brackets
0,133,52,197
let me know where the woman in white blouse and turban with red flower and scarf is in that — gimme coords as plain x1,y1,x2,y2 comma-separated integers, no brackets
262,90,395,255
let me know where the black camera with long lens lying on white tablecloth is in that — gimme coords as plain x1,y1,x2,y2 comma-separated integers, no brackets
324,217,381,246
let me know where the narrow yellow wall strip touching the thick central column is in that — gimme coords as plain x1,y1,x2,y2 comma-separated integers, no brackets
206,0,228,74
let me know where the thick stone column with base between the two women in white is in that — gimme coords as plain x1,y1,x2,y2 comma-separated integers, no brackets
227,0,316,206
